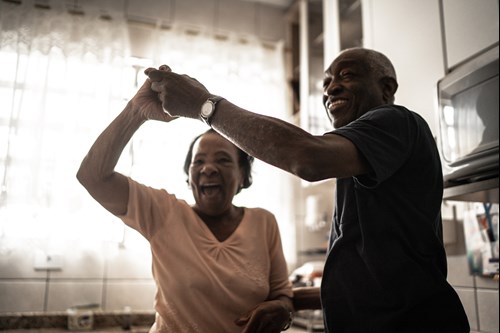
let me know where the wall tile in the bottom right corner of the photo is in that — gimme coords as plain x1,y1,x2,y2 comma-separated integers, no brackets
477,289,499,333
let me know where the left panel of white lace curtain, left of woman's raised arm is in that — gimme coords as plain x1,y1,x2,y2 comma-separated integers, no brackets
0,1,133,237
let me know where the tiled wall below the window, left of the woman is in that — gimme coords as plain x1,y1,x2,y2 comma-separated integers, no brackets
0,230,156,313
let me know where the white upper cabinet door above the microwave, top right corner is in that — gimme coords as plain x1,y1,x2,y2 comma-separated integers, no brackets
442,0,498,71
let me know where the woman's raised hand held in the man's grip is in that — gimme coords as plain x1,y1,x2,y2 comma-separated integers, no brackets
129,66,174,122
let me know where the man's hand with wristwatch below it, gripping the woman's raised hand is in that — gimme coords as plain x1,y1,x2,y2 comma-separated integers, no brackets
144,65,210,119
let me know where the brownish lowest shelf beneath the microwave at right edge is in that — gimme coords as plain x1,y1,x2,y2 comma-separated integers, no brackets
443,177,498,203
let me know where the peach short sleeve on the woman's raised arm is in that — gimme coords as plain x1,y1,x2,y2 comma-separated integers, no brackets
118,178,178,240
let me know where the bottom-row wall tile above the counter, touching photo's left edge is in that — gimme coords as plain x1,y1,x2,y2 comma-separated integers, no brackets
0,280,45,312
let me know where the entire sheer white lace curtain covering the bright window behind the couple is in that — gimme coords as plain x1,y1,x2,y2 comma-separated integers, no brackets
0,0,294,260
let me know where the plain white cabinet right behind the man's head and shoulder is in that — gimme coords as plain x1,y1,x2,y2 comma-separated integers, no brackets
361,0,444,136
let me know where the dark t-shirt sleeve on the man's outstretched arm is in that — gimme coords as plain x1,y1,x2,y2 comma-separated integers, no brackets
331,106,415,187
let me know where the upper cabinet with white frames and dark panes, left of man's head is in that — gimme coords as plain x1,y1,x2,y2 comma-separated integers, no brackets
286,0,362,135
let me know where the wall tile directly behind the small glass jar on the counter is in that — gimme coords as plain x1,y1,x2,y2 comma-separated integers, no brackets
47,280,103,311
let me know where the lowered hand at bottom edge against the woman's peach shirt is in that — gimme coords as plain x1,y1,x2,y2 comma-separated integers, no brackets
235,300,292,333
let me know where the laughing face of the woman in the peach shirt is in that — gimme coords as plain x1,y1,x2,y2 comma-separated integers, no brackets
189,132,243,216
